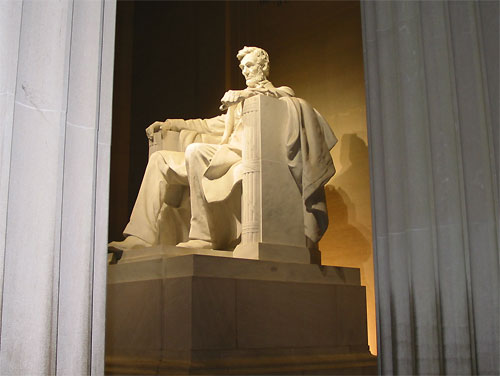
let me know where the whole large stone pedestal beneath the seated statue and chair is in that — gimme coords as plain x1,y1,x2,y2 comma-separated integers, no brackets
106,247,377,375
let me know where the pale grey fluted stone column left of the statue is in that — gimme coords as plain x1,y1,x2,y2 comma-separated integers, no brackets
0,0,115,375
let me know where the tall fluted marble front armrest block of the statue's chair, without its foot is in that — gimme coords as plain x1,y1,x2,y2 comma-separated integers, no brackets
238,95,306,247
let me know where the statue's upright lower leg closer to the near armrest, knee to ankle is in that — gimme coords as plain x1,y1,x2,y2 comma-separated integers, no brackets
182,143,220,243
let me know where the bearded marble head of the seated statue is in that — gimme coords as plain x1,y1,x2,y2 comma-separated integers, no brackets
236,46,269,87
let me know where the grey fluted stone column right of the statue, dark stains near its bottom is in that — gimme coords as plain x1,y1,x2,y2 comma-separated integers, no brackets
362,1,500,374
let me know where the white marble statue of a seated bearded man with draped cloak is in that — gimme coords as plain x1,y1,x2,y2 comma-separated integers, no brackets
109,47,337,254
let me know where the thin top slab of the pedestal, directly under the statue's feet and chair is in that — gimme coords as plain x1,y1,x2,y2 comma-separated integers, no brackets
108,250,360,286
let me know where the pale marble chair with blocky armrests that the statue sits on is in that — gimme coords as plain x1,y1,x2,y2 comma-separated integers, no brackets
149,95,320,263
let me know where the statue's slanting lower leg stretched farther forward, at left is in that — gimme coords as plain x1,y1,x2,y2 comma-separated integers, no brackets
123,150,188,245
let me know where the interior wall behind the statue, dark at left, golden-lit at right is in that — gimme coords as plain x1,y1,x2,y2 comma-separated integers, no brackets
109,1,376,353
